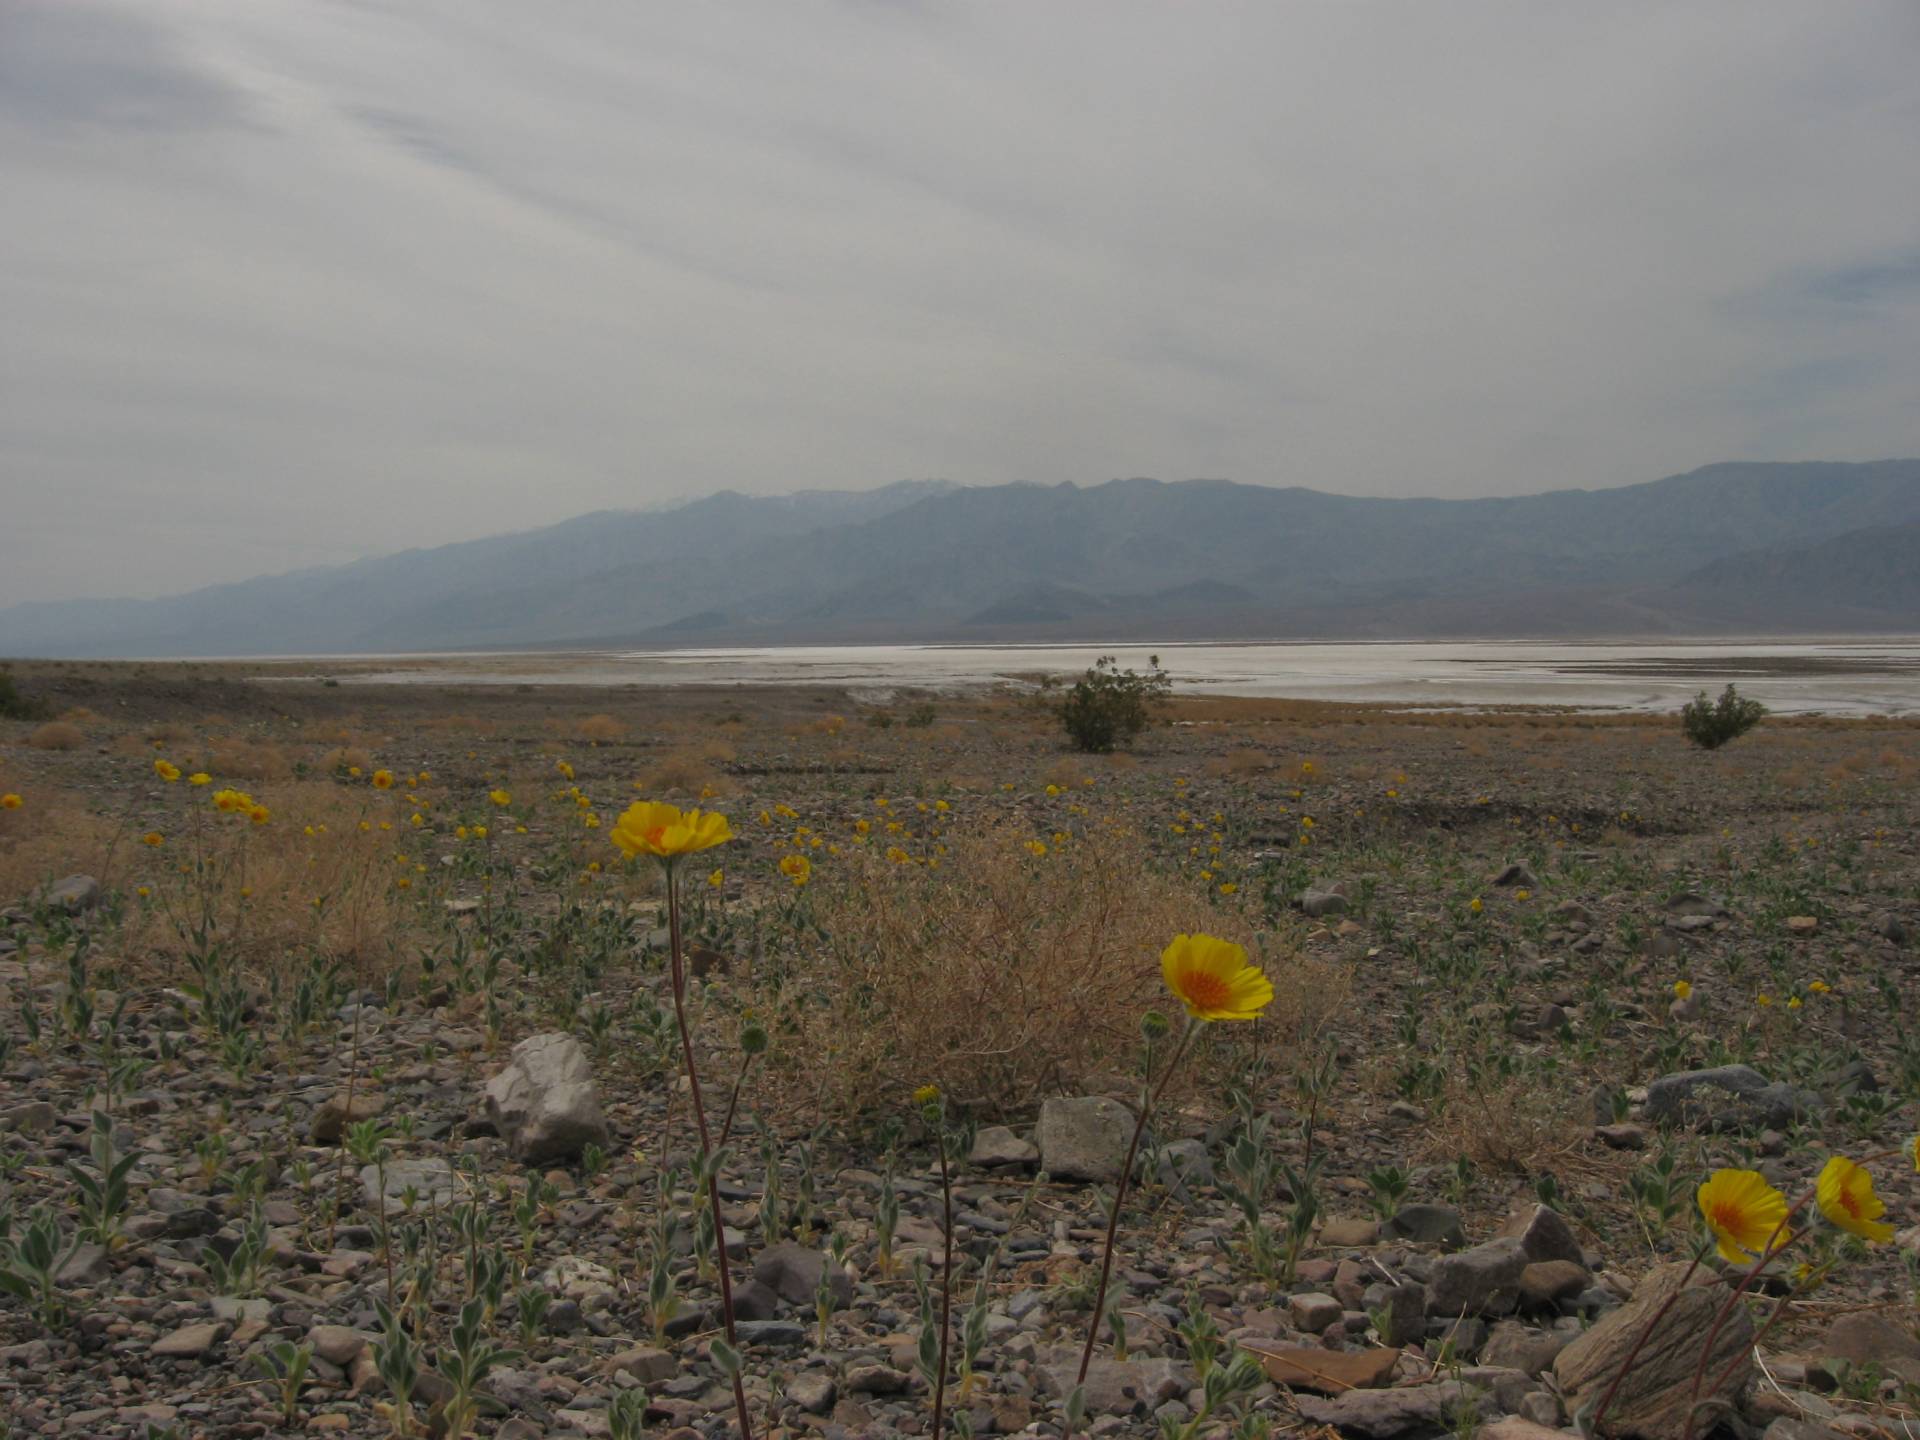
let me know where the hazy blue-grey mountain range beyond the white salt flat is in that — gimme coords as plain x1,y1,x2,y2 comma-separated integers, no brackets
0,461,1920,655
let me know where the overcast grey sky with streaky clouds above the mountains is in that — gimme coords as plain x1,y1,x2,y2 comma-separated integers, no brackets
0,0,1920,603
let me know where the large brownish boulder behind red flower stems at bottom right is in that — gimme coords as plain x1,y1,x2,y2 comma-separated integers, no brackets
1553,1265,1753,1440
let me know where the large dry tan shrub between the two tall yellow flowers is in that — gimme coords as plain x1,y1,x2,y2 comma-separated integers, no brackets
776,824,1346,1116
